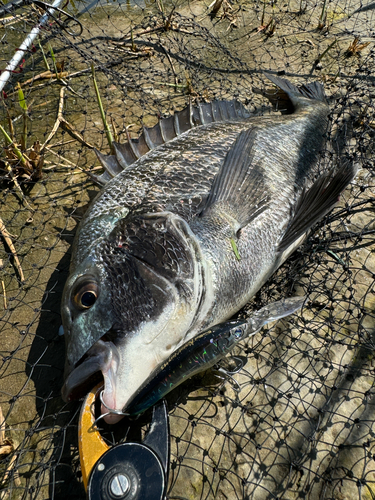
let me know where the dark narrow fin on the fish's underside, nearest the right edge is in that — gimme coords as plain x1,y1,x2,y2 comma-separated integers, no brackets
278,161,357,253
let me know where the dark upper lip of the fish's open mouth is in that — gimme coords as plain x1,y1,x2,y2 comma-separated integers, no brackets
61,340,119,402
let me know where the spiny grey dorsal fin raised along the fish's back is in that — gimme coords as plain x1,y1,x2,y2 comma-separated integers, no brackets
91,101,251,186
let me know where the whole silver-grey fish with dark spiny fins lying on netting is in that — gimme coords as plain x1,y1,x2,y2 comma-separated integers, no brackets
61,74,356,423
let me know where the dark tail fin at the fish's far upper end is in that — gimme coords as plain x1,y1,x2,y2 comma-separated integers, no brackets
264,75,327,113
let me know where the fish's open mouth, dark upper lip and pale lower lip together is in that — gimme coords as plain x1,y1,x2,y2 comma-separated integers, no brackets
61,340,120,423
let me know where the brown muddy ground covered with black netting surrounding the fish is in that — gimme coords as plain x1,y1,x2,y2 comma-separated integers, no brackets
0,0,375,500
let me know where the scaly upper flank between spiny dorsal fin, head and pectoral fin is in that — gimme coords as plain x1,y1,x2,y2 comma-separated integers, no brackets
72,121,248,263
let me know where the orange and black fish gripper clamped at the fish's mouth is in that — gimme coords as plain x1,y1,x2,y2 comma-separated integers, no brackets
79,385,170,500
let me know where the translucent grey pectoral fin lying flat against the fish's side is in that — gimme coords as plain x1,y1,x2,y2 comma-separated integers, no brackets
199,127,270,232
